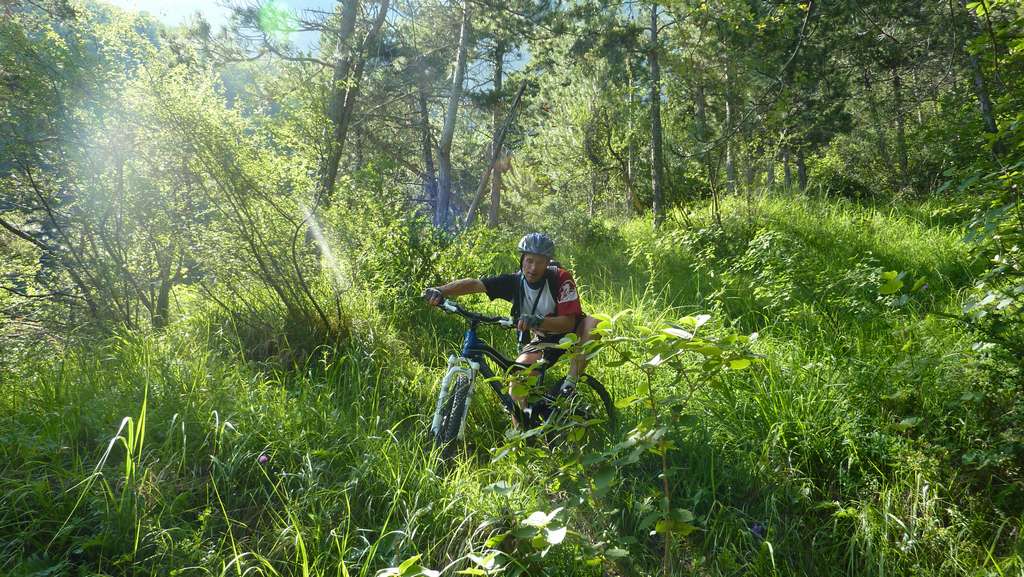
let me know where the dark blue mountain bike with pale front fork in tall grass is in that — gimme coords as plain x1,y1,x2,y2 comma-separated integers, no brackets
430,299,615,460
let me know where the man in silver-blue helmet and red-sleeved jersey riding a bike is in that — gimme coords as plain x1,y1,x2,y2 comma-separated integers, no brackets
423,233,597,418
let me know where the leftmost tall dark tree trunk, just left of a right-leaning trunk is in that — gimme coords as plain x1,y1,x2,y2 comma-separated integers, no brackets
314,0,359,204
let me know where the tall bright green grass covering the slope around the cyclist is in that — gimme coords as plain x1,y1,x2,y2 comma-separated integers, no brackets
0,199,1020,575
